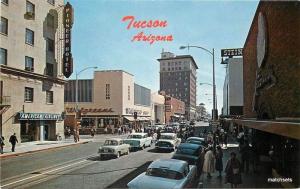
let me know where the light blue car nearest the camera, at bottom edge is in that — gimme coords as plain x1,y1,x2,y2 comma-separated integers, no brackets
127,159,197,189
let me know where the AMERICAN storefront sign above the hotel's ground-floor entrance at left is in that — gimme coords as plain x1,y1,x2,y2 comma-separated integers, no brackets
19,112,63,120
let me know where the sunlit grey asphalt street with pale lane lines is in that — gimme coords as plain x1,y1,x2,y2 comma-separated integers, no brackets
1,123,208,189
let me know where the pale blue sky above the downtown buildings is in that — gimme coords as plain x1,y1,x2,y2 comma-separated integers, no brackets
69,0,258,112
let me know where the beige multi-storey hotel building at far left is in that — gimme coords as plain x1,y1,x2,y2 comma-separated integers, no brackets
0,0,65,144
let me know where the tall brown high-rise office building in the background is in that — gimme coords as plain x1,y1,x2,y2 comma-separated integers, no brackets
158,52,198,120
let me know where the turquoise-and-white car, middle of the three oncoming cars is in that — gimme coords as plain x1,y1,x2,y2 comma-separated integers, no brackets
124,133,152,149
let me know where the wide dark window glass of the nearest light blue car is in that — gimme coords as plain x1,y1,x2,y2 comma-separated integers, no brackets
146,168,183,180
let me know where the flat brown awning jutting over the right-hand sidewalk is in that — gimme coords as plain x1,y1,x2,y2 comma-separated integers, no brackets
234,119,300,140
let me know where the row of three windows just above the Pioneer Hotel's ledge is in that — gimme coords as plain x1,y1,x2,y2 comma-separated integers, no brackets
0,48,54,77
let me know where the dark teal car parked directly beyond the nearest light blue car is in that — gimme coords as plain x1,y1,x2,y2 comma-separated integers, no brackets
172,143,202,175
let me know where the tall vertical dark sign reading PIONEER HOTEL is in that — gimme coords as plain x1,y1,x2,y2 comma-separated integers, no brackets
63,2,73,78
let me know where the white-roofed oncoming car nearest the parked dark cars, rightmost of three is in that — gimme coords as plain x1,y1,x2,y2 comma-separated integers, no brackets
155,133,181,151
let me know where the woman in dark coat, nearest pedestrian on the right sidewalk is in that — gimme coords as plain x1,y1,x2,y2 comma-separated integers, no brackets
225,152,242,188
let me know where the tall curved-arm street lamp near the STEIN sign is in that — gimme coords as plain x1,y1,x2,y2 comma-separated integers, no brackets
179,45,218,121
